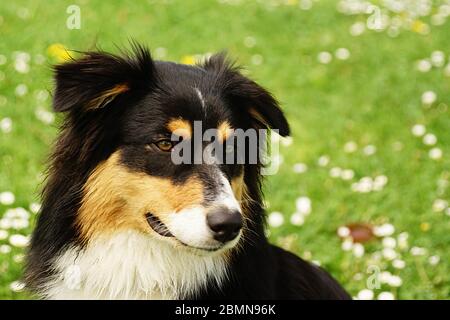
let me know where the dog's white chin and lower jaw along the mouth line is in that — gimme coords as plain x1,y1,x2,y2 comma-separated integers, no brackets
145,213,241,256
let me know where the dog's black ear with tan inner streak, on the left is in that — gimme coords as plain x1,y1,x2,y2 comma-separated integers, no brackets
53,44,155,112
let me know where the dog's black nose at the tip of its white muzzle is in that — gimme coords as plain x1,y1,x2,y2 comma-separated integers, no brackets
206,207,242,242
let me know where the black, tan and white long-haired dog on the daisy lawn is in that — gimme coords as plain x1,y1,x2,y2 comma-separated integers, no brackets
25,43,350,299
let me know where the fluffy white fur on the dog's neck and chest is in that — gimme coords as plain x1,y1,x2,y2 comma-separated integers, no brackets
42,231,226,299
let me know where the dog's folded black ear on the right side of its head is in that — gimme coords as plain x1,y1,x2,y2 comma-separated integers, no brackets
202,53,290,136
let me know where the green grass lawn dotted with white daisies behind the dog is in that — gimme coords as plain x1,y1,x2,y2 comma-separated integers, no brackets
0,0,450,299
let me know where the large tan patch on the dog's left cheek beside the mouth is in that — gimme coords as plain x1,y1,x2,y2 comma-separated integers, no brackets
76,151,203,241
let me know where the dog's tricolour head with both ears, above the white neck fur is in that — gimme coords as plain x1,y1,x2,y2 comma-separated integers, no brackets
54,48,289,253
